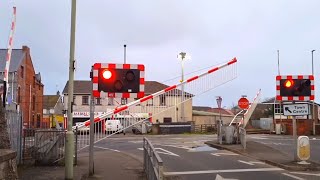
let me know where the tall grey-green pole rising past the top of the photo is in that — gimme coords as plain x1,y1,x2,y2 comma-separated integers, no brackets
65,0,77,179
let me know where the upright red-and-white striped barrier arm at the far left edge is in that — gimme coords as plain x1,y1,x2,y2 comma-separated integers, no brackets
3,7,16,102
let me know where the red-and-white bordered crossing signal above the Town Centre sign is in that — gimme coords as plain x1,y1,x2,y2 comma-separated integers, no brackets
276,75,314,101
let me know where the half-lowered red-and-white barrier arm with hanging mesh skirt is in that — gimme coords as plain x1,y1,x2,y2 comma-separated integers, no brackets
73,58,237,151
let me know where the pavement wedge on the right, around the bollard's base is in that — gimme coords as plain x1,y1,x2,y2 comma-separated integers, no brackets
206,140,320,171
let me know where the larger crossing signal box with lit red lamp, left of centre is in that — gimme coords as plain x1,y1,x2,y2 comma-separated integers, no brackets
93,63,144,98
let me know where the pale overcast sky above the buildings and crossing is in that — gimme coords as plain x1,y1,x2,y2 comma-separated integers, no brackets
0,0,320,107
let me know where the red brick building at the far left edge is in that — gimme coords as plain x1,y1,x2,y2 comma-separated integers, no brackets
0,46,44,128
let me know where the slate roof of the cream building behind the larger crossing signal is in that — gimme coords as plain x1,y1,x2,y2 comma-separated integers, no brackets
62,80,189,95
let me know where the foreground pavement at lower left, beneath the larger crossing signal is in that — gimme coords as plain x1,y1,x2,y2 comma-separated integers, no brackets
18,150,146,180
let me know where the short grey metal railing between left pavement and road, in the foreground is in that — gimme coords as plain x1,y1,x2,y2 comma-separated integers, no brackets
143,138,163,180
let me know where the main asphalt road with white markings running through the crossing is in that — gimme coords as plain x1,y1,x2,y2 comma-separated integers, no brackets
78,134,320,180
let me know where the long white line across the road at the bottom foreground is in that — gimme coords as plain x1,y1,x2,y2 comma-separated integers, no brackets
163,168,283,176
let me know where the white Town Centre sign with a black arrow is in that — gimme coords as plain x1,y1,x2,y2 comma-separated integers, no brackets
283,104,309,116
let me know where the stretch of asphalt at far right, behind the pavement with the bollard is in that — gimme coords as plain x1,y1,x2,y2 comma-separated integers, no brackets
247,135,320,164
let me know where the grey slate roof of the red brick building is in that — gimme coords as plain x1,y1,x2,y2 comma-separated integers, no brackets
0,49,26,72
